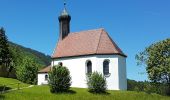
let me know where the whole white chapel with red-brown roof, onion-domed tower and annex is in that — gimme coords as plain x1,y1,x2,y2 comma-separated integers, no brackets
38,2,127,90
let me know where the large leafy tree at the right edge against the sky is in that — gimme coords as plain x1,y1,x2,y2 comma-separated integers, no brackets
136,38,170,84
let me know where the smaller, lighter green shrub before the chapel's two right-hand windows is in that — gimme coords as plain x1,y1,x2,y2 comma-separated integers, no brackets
87,72,107,93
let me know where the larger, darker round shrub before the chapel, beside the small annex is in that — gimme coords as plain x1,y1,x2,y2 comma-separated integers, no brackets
48,65,71,93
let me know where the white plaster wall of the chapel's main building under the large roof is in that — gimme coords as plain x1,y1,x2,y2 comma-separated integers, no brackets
51,55,127,90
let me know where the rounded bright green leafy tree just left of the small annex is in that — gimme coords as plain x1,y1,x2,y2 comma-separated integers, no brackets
16,57,38,84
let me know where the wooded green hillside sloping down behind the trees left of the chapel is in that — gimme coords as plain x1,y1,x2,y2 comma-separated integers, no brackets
0,42,51,78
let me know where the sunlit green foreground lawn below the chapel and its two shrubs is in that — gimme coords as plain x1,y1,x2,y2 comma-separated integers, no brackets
0,77,170,100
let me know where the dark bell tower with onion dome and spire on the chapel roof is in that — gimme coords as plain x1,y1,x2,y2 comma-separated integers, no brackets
58,2,71,41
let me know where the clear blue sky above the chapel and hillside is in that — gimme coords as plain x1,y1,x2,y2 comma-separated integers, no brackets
0,0,170,81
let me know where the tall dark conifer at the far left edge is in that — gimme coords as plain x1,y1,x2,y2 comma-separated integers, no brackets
0,28,13,77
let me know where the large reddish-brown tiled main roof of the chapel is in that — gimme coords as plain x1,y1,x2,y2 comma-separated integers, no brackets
52,29,126,58
